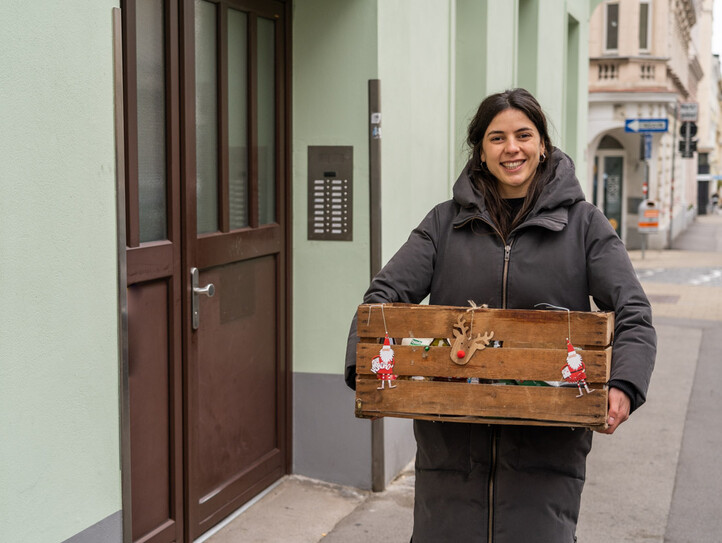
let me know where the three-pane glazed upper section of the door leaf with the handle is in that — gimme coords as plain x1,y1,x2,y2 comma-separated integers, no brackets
195,0,279,234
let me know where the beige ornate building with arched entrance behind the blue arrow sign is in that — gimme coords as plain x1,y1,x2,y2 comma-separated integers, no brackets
588,0,719,248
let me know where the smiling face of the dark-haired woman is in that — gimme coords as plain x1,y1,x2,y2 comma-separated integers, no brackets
481,109,546,198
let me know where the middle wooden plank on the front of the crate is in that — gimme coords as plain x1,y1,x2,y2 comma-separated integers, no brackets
356,342,612,383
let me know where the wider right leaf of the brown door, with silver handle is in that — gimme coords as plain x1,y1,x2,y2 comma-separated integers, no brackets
184,0,290,537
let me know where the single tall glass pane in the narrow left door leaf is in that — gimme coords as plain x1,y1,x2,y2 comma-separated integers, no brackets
135,0,168,243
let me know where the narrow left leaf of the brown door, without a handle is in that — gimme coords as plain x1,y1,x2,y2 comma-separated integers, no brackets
122,0,185,543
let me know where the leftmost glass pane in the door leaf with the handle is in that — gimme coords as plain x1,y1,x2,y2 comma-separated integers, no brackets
195,0,218,234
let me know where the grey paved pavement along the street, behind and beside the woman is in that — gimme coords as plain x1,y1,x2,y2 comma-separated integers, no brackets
197,216,722,543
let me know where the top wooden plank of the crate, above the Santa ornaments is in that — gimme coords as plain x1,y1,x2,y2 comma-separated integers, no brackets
357,304,614,348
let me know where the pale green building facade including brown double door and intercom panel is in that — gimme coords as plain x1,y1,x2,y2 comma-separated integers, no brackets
0,0,598,543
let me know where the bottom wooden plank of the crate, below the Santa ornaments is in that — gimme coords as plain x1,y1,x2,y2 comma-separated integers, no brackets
356,378,607,427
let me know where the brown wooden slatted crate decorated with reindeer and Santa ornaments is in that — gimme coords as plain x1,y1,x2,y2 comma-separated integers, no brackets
356,304,614,429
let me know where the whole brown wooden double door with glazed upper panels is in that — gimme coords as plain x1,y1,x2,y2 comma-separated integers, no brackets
122,0,290,542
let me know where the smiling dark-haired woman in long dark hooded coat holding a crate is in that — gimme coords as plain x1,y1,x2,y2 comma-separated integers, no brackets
346,89,656,543
